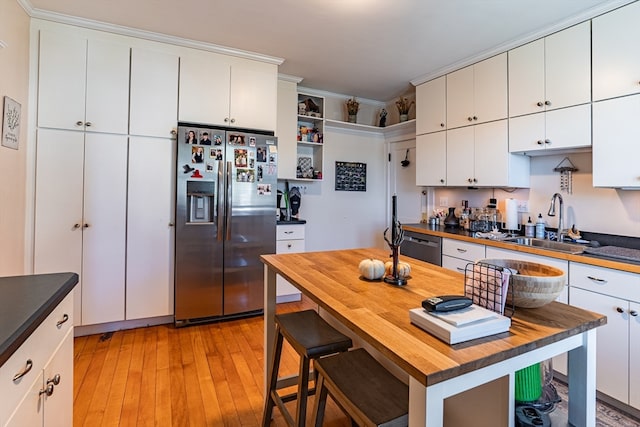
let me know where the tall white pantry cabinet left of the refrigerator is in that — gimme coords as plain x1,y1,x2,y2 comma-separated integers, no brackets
34,26,179,325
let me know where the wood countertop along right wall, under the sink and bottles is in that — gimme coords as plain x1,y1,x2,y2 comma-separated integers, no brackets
402,224,640,274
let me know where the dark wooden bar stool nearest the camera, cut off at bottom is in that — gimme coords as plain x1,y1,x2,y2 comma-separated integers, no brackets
313,348,409,427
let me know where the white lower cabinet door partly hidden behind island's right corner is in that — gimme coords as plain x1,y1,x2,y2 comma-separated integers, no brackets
569,287,637,403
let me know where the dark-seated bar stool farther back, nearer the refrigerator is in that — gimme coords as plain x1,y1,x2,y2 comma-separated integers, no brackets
262,310,352,427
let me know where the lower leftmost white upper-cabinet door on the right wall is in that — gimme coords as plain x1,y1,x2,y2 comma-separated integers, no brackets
416,131,447,187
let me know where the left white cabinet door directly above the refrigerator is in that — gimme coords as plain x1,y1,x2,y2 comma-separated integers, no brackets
178,51,231,125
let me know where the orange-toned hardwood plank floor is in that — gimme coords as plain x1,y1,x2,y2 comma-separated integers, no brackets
73,300,351,427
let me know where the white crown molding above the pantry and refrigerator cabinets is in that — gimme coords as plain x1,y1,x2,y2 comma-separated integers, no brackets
17,0,284,66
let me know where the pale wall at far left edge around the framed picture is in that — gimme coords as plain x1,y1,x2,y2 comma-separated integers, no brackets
0,0,29,276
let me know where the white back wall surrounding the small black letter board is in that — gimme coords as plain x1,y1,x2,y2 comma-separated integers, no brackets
288,128,387,252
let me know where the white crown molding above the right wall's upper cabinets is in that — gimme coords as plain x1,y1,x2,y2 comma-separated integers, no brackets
410,0,637,86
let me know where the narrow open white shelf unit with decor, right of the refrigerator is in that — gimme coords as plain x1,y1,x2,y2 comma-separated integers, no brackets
296,92,325,180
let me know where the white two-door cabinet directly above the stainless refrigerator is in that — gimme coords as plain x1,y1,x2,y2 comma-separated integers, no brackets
178,51,278,130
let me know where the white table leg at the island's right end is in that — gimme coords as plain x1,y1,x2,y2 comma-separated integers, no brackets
568,329,596,427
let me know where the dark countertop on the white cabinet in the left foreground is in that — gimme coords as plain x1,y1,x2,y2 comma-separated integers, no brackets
0,273,78,366
